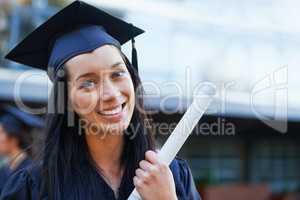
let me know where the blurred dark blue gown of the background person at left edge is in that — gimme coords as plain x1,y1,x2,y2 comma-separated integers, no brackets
0,158,32,193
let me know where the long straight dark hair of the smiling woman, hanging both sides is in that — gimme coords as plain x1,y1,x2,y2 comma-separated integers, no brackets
41,53,155,200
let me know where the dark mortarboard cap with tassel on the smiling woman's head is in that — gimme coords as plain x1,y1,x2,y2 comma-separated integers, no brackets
5,1,144,80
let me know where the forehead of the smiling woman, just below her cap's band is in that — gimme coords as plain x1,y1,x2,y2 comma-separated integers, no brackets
65,45,124,77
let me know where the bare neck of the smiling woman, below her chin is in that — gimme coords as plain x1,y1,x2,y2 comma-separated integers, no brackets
85,130,124,172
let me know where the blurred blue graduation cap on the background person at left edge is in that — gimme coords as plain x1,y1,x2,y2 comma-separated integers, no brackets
0,106,45,135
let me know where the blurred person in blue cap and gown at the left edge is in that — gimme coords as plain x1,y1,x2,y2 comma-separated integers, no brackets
0,106,43,192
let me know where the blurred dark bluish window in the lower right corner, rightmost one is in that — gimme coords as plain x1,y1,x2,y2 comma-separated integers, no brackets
251,140,300,192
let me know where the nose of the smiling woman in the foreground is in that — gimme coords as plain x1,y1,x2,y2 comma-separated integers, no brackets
99,80,121,101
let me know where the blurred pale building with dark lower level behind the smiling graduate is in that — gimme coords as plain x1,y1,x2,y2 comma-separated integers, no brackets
0,0,300,200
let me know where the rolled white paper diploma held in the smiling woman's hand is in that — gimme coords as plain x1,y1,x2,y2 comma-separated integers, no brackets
127,96,212,200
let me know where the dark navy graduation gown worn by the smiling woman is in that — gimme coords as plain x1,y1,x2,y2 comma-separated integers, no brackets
0,158,200,200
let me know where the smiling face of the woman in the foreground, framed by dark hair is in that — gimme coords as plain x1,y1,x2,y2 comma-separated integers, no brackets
65,45,135,134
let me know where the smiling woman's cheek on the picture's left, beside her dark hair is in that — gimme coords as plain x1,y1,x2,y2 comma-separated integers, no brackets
70,89,98,115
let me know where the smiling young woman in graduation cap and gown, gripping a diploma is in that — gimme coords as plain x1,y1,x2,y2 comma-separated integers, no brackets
0,1,200,200
